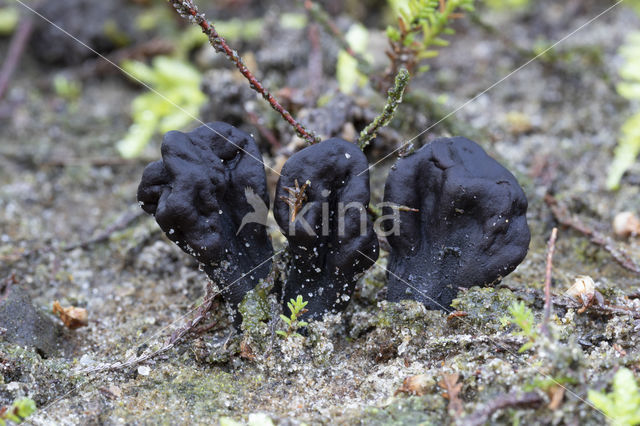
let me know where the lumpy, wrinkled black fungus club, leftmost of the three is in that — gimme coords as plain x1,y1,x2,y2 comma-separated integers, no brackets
138,122,273,321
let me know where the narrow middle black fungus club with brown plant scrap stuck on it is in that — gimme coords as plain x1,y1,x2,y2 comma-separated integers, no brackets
274,138,378,319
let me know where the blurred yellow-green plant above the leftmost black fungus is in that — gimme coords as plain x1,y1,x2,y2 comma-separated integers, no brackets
117,56,207,158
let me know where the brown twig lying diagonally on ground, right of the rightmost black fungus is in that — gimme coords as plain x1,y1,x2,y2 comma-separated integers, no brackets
544,194,640,274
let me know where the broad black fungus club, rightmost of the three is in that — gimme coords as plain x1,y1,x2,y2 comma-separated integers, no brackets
383,137,530,310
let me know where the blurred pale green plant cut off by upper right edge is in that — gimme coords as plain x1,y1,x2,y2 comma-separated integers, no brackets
607,32,640,190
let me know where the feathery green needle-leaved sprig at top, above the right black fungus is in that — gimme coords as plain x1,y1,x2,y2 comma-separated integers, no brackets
387,0,474,77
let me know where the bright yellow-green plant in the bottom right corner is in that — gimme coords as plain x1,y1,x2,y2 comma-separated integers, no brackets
589,368,640,426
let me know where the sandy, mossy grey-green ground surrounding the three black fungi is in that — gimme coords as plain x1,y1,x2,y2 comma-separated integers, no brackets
0,0,640,424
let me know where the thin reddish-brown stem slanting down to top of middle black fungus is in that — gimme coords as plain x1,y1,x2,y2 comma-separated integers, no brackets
168,0,320,144
